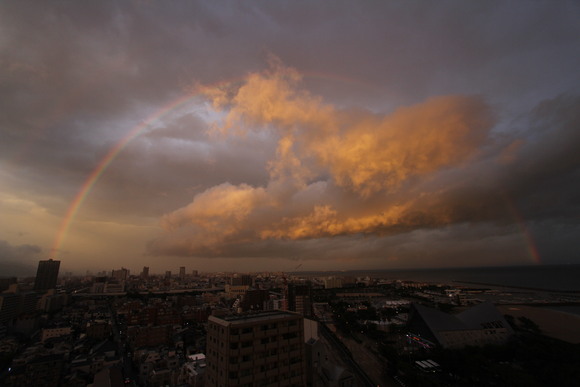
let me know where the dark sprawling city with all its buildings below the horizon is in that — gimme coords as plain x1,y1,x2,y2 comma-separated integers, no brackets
0,259,580,387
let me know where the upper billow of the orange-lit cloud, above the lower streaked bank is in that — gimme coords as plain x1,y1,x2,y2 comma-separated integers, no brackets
206,58,493,196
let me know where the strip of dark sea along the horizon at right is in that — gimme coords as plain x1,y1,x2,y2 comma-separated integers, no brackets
297,265,580,292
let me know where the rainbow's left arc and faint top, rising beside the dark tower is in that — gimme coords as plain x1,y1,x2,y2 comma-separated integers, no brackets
50,72,369,256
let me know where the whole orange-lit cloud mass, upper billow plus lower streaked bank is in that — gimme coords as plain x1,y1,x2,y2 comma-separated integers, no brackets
152,60,493,252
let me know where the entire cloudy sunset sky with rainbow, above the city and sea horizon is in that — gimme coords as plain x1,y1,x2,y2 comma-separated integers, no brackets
0,0,580,275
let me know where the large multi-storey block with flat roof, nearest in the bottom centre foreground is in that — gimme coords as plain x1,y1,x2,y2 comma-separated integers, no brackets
206,311,306,387
